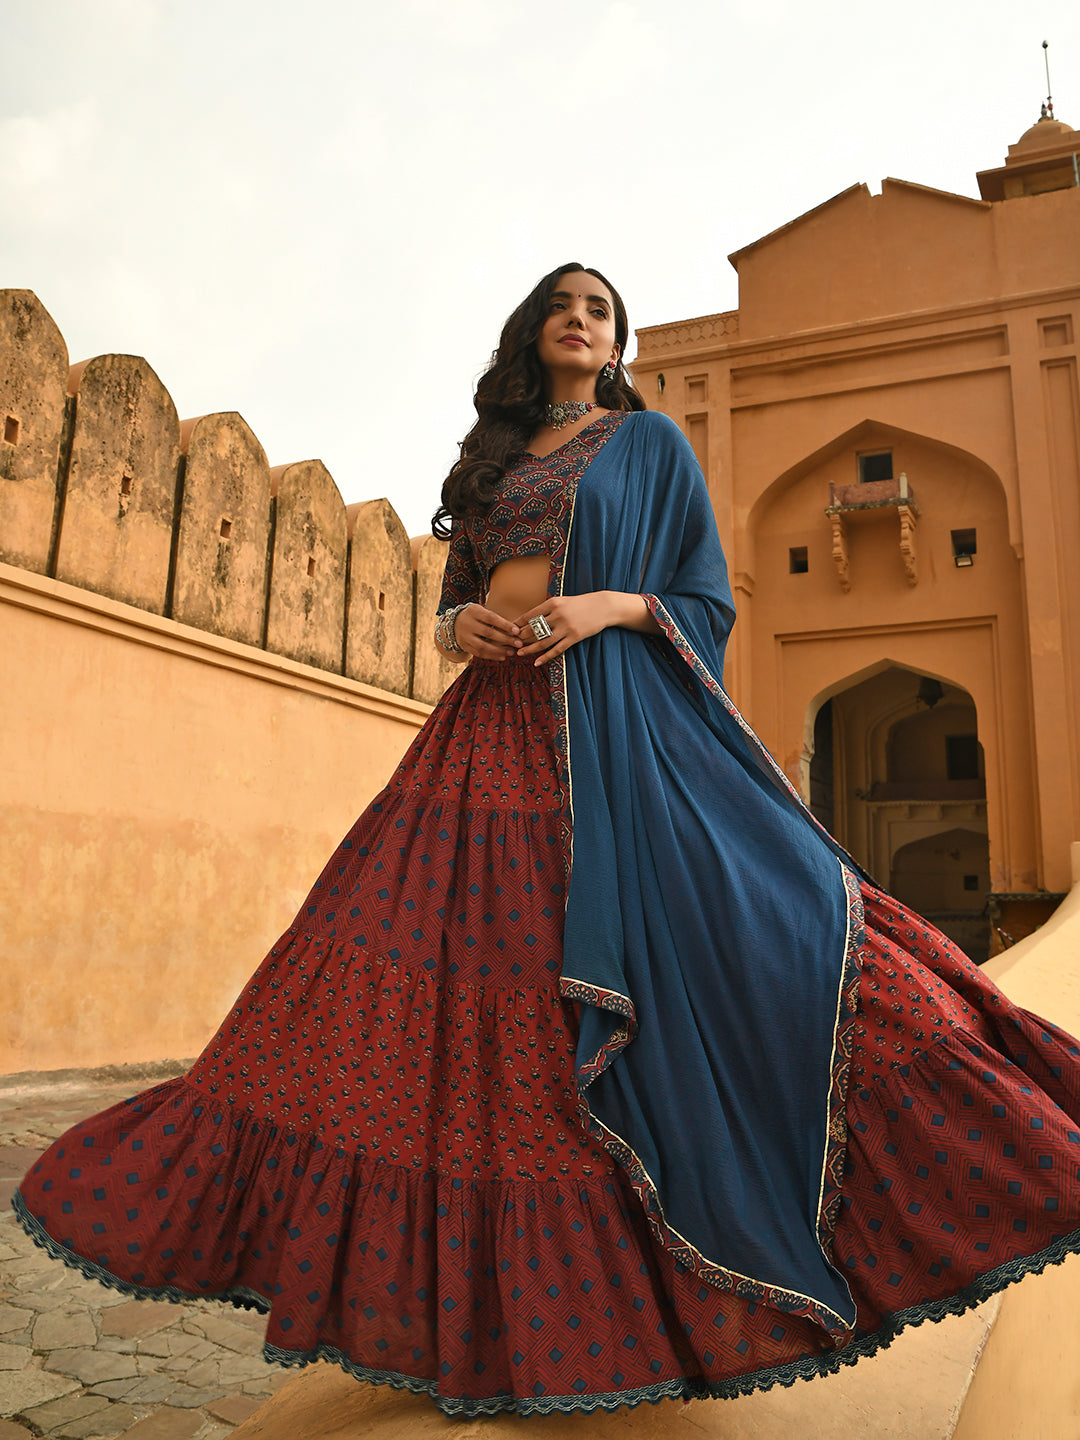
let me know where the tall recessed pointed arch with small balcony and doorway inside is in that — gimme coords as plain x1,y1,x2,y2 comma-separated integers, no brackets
729,419,1037,959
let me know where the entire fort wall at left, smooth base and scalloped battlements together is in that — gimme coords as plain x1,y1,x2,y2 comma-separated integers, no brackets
0,291,455,1073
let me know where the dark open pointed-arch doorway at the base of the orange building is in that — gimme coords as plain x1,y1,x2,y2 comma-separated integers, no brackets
809,665,991,963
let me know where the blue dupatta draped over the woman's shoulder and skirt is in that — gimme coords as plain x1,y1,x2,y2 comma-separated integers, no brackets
556,412,861,1344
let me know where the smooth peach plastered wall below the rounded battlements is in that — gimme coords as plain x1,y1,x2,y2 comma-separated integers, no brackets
0,564,428,1073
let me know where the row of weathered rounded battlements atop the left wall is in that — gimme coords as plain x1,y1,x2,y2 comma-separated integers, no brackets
0,289,456,704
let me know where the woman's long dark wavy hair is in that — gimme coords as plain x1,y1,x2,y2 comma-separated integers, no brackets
431,264,645,540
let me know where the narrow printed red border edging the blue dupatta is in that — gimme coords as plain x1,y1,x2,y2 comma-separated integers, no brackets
547,416,864,1349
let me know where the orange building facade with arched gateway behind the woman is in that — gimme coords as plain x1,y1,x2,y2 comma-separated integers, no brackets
634,117,1080,956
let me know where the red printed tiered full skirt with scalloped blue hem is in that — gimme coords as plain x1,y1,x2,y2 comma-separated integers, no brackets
16,661,1080,1414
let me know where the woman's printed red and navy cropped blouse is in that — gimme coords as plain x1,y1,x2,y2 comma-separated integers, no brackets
439,410,626,615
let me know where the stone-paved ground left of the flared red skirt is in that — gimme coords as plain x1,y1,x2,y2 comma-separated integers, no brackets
0,1074,289,1440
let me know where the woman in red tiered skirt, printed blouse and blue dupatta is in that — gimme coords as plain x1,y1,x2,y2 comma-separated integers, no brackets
16,265,1080,1414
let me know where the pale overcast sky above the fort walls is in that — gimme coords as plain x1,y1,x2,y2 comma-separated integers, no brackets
0,0,1080,534
